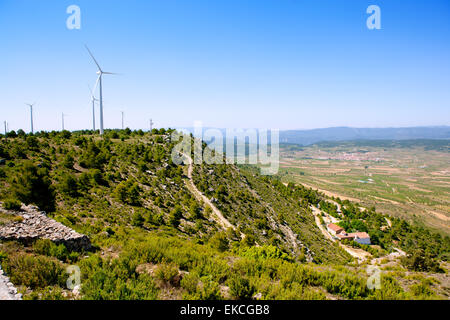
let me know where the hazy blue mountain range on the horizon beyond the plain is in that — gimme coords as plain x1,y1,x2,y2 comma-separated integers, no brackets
280,126,450,145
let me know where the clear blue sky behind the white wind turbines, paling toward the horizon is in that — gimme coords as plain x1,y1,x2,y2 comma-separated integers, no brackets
0,0,450,131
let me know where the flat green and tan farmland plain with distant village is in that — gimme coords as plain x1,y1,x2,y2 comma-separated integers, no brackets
279,142,450,235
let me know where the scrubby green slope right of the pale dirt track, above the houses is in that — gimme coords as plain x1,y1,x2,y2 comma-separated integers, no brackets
194,164,349,263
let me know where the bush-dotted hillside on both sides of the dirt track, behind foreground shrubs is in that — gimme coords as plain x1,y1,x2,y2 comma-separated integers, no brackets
2,131,349,263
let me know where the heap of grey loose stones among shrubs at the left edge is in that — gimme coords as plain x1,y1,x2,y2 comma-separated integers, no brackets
0,206,91,251
